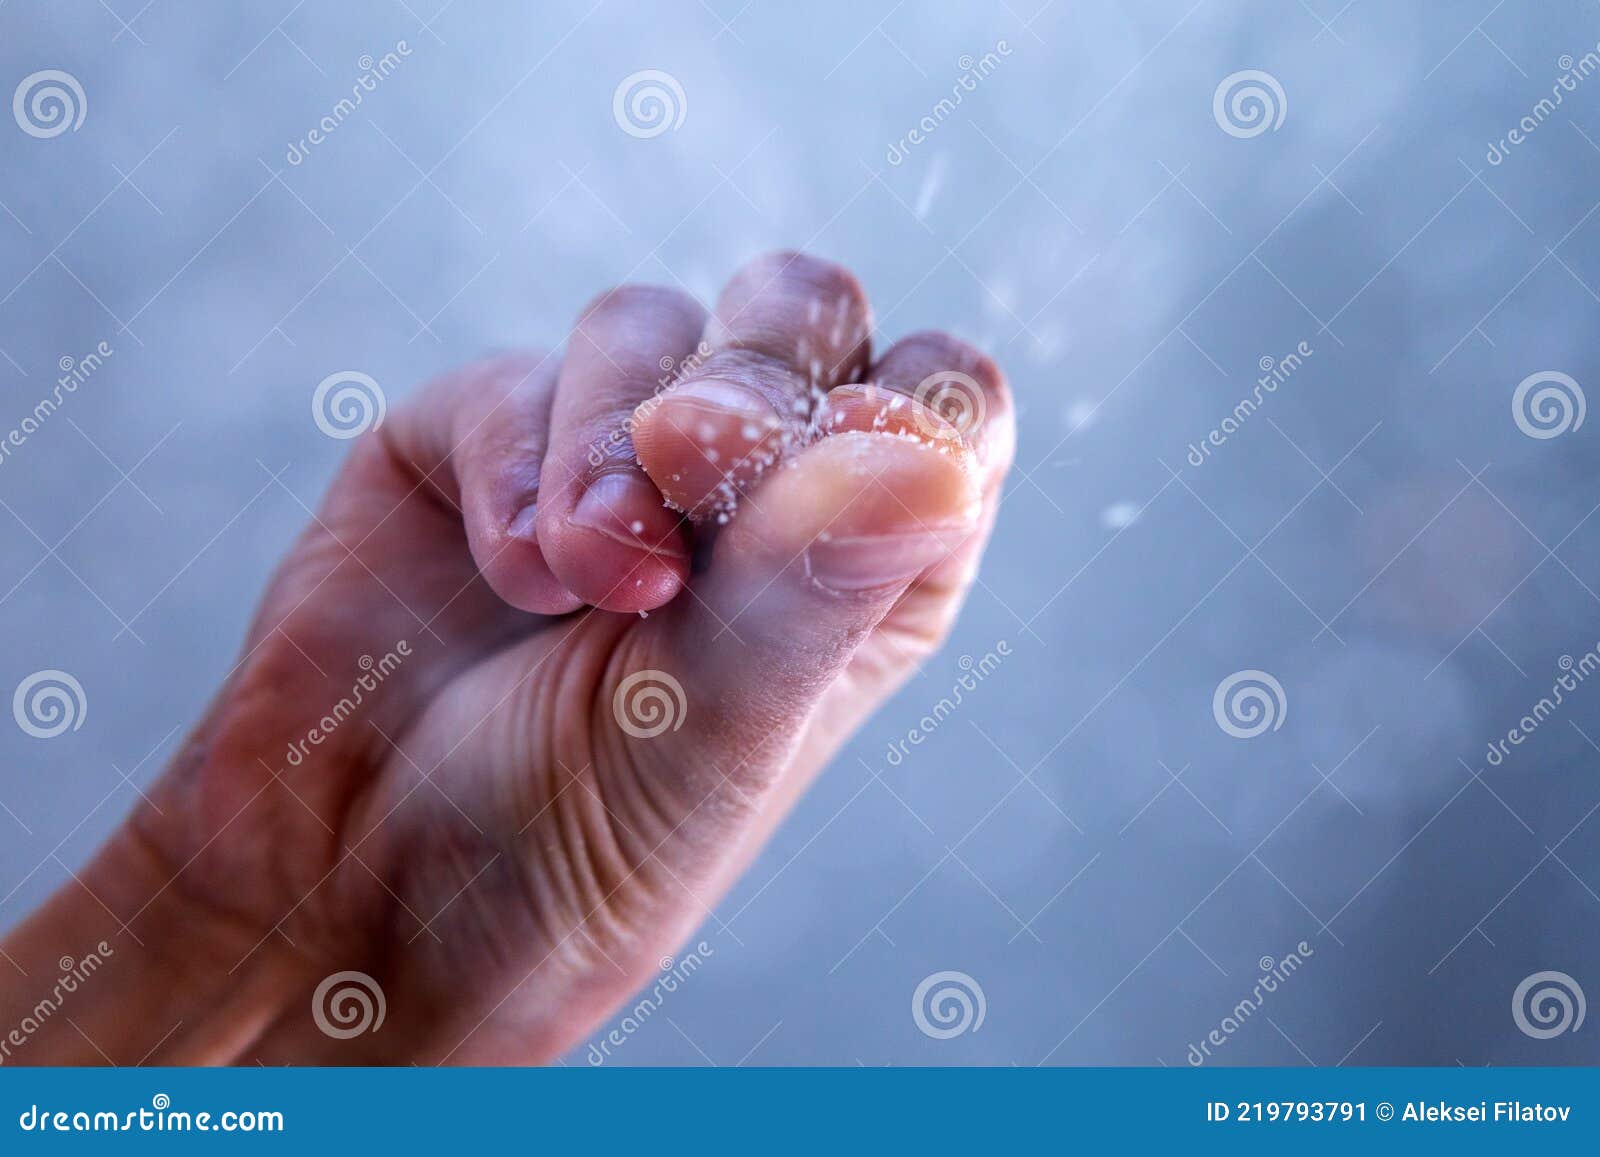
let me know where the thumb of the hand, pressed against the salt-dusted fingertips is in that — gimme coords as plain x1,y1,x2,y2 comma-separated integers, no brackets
627,416,982,802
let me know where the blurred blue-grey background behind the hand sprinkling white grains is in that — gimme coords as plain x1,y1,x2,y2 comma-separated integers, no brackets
0,0,1600,1066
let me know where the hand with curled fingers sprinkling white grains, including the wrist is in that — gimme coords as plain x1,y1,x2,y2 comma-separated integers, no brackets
0,253,1013,1064
